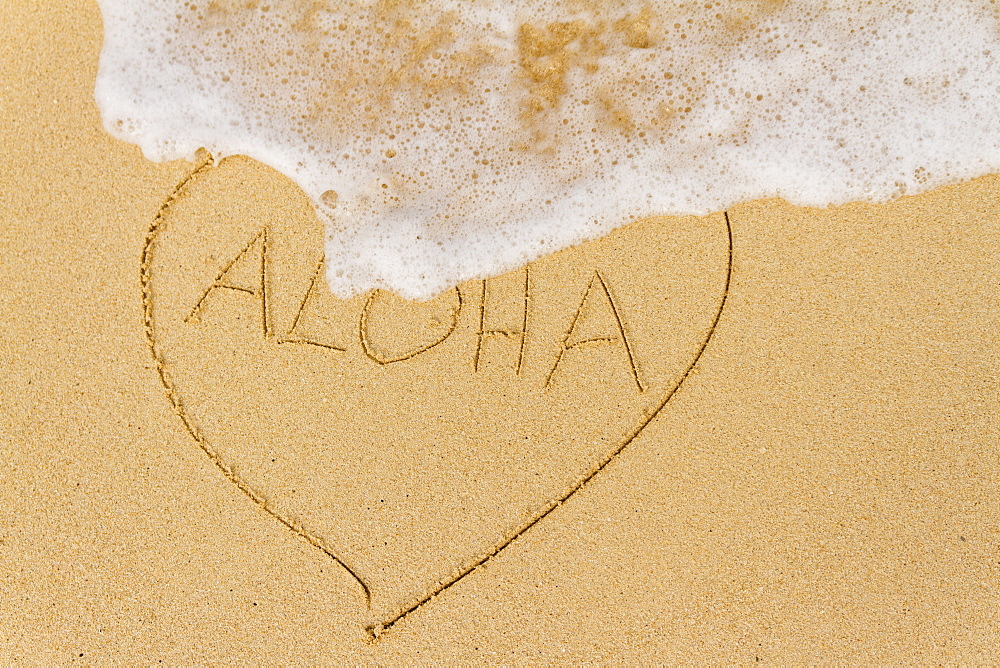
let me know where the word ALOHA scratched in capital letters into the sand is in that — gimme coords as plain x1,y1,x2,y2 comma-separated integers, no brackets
185,227,646,393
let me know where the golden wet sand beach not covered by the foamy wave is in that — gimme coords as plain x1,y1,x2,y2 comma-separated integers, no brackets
0,1,1000,664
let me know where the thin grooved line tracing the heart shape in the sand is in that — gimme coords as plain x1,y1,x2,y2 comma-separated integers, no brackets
139,151,733,642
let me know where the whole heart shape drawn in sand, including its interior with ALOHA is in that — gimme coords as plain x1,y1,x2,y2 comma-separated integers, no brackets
142,158,732,638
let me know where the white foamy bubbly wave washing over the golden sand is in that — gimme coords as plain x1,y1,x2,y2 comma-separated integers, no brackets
96,0,1000,298
